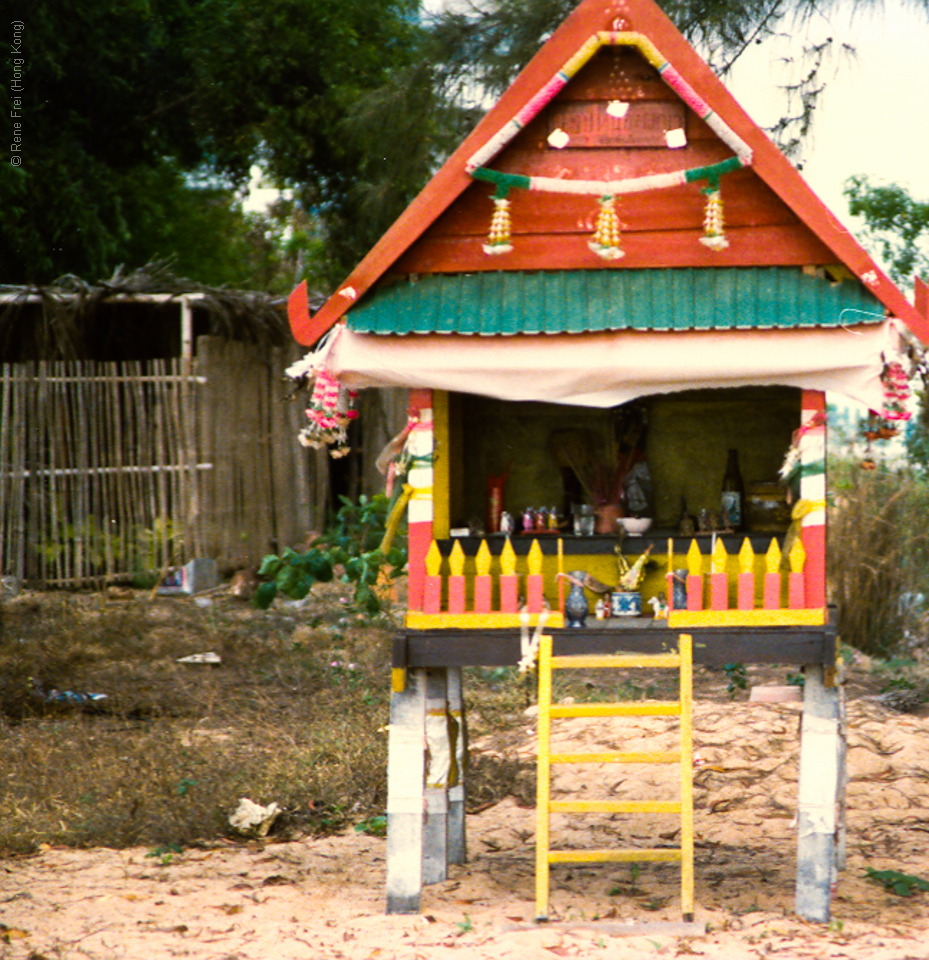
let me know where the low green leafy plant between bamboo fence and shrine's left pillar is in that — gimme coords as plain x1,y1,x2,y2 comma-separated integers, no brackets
255,494,407,615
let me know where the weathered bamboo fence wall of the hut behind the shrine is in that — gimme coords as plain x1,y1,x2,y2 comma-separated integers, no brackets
0,337,325,587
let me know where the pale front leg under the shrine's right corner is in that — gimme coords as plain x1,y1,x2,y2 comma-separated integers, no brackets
796,664,840,923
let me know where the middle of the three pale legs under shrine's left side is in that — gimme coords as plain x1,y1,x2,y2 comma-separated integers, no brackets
423,667,452,883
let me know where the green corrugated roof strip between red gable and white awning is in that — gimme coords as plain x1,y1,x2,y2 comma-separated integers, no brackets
347,267,884,336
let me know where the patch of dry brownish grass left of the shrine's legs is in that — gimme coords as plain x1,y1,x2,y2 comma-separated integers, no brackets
0,594,390,853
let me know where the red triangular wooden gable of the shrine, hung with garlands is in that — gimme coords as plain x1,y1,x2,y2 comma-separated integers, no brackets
290,0,929,344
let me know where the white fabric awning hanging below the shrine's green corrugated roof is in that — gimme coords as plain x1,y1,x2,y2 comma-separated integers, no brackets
296,320,905,410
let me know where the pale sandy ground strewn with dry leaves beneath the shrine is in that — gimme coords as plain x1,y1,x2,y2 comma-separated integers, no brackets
0,700,929,960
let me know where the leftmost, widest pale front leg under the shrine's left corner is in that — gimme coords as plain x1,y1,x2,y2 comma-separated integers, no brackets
387,669,426,913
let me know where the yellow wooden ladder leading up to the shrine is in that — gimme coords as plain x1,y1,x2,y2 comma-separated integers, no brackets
536,634,694,921
